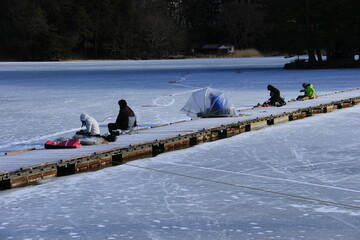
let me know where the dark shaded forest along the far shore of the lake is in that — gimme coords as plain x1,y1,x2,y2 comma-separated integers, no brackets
0,0,360,62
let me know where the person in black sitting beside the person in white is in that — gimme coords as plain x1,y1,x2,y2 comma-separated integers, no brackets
108,99,136,134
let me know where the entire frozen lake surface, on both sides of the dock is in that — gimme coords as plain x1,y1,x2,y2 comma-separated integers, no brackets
0,58,360,239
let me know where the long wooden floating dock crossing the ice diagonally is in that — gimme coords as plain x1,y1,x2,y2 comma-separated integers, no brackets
0,89,360,190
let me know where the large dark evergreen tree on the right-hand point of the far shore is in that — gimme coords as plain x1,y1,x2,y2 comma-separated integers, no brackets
266,0,360,62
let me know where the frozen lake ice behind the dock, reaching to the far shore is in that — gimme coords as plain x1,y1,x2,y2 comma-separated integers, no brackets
0,57,360,153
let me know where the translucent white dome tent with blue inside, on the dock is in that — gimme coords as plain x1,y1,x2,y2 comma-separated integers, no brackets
181,87,236,117
